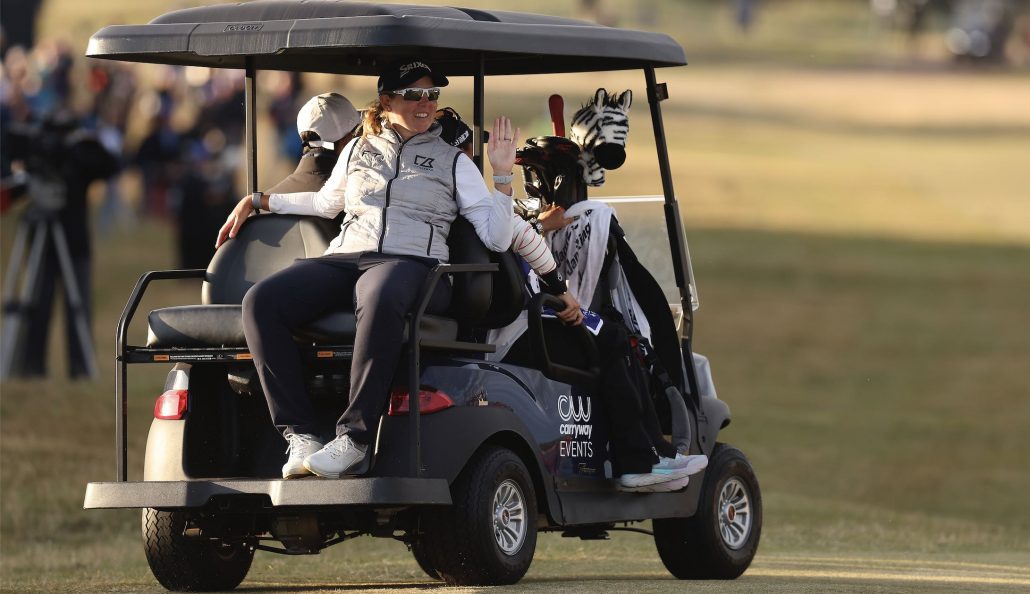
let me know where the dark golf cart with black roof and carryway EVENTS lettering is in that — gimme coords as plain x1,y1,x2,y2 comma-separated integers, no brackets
84,0,762,590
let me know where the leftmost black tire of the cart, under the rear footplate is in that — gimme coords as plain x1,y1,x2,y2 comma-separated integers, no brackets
143,509,254,592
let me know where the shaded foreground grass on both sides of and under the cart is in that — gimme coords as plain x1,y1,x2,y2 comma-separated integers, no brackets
0,224,1030,592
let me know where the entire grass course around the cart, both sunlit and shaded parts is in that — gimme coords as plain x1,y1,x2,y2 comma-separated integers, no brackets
0,0,1030,594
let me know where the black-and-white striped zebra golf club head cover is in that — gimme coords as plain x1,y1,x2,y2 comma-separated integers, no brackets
569,89,633,186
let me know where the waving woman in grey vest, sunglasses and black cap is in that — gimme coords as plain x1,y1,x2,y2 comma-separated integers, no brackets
217,58,519,479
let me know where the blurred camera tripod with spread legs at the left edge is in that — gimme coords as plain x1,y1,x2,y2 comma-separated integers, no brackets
0,204,99,380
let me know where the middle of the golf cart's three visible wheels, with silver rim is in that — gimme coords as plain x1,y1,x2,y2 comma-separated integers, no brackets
421,447,537,586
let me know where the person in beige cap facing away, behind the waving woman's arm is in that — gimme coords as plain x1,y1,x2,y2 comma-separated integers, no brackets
263,93,362,195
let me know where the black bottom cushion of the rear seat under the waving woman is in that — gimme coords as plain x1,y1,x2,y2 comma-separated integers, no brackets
146,305,457,348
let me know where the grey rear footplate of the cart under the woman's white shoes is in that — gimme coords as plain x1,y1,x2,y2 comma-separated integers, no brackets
82,477,451,510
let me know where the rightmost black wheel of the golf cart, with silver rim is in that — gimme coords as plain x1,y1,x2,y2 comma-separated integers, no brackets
654,444,762,580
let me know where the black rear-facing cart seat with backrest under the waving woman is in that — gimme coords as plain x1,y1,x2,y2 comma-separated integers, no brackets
147,215,521,348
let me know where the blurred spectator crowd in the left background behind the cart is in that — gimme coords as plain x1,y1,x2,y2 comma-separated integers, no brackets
0,37,309,268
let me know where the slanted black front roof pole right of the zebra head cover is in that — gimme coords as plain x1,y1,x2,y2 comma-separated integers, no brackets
644,67,693,341
